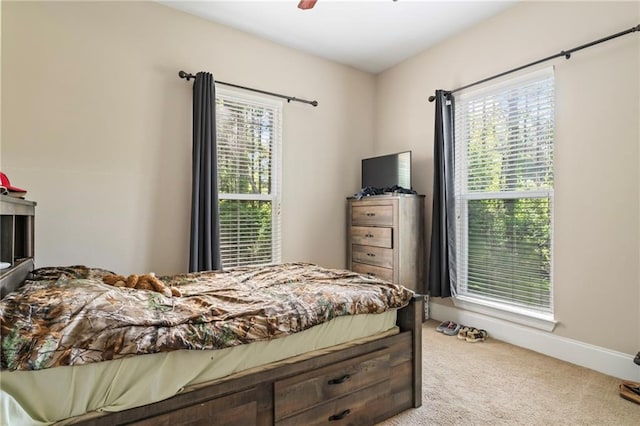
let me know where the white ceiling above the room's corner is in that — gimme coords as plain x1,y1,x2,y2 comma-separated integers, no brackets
158,0,518,74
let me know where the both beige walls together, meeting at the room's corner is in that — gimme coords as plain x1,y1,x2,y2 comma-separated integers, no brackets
0,1,640,354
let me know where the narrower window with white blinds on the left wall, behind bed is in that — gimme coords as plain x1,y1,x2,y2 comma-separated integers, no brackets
216,90,282,267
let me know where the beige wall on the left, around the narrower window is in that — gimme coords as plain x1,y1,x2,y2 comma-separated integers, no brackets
0,1,374,274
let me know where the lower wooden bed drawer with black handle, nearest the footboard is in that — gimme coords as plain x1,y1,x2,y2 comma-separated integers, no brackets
276,380,391,426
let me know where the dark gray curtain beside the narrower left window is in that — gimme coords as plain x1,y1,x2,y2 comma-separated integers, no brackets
189,72,222,272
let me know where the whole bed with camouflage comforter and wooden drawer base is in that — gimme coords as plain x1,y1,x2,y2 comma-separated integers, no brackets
0,262,423,425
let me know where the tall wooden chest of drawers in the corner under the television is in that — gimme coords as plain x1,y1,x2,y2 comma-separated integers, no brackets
347,194,426,294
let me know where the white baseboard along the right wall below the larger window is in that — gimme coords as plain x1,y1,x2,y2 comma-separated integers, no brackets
429,303,640,382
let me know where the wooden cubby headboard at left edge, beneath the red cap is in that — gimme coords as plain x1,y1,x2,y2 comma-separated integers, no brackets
0,195,36,297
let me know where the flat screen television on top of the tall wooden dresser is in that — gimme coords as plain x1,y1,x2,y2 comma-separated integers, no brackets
362,151,411,189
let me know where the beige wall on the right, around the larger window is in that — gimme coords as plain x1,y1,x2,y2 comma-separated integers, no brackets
374,2,640,354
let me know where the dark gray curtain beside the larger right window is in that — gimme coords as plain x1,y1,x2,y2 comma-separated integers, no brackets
429,90,456,297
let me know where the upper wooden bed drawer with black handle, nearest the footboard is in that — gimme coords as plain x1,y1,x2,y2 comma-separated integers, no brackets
274,350,390,424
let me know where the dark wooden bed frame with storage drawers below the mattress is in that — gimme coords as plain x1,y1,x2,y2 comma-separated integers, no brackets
58,295,423,426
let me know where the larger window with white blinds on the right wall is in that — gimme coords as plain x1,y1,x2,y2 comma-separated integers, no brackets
455,69,554,320
